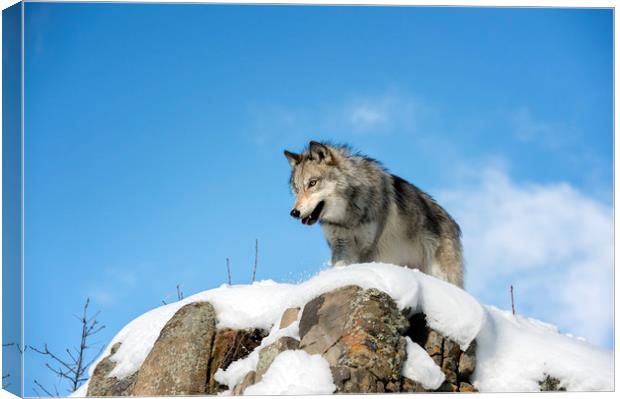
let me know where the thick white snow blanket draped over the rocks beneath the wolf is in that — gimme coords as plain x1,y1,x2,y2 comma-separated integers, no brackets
85,263,613,393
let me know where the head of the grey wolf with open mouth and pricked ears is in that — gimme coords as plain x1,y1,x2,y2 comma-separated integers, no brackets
284,141,341,225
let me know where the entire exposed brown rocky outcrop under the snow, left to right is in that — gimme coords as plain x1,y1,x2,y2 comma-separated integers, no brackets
88,286,476,396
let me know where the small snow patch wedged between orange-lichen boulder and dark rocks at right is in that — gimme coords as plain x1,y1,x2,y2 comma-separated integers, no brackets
401,337,446,390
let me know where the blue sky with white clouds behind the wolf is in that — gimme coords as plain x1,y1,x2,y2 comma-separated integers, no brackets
17,3,613,395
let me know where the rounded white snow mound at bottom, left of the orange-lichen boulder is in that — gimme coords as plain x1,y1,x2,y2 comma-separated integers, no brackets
244,350,336,395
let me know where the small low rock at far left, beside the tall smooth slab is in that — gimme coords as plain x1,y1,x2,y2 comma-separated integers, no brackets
86,342,137,396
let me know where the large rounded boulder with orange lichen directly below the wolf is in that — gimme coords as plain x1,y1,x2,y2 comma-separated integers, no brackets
299,286,409,393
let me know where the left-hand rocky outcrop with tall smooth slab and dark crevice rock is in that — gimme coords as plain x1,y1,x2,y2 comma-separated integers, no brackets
87,302,266,396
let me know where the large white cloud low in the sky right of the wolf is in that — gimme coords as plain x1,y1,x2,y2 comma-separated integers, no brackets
438,169,614,345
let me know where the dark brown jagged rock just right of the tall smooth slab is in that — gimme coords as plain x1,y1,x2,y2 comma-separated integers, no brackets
206,328,267,394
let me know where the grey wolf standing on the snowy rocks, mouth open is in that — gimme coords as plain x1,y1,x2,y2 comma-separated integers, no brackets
284,141,464,288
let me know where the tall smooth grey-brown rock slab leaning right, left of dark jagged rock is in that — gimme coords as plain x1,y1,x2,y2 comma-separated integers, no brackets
132,302,216,396
